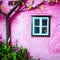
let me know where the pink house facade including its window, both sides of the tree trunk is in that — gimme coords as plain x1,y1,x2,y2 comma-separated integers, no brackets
0,2,60,60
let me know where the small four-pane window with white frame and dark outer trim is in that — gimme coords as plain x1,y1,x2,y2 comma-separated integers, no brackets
32,16,50,36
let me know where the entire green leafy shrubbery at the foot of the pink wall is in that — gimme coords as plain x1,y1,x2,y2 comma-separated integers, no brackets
0,43,31,60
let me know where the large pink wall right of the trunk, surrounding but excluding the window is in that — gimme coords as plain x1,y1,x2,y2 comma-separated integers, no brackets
11,4,60,60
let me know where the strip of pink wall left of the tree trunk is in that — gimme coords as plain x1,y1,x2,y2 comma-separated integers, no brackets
0,14,6,42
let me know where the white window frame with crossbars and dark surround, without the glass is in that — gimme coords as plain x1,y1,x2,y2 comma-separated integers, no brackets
32,16,50,36
